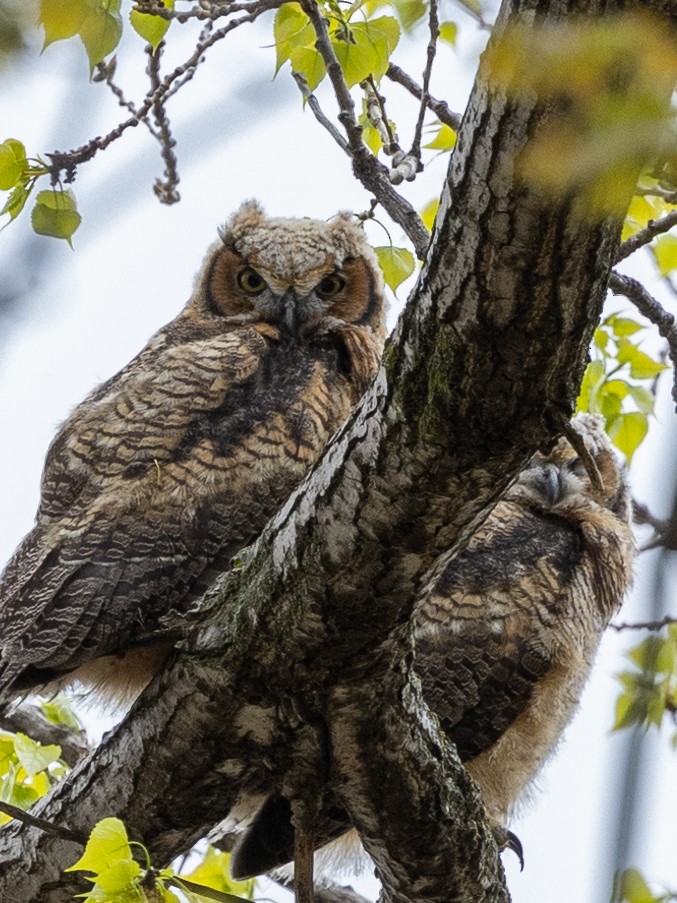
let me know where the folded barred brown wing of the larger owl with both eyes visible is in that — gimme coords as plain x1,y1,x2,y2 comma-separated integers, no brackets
0,329,265,698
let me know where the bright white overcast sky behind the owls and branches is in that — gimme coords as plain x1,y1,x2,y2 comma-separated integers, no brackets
0,5,677,903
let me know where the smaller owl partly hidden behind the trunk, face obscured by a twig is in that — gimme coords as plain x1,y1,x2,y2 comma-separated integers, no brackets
231,415,634,877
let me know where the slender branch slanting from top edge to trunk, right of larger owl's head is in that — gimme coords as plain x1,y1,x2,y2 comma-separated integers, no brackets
301,0,430,259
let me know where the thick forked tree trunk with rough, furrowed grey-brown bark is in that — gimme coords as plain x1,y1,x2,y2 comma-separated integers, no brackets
0,0,674,903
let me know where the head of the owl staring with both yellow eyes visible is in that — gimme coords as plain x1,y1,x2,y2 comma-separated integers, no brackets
189,201,386,339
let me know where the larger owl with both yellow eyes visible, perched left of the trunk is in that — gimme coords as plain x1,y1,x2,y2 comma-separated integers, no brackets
0,202,385,703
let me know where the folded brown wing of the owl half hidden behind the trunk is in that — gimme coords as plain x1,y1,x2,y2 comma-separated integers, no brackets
415,501,583,761
